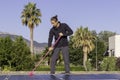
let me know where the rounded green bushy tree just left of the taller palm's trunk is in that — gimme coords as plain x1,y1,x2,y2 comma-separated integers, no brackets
11,37,34,71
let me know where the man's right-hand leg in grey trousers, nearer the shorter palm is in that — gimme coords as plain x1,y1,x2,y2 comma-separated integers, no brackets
62,46,70,73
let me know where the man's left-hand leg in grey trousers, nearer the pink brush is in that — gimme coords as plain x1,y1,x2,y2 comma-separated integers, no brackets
50,48,60,74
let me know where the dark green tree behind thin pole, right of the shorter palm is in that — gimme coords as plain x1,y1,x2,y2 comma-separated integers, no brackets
88,37,107,70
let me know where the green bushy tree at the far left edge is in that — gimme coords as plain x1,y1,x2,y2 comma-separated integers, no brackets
0,37,13,69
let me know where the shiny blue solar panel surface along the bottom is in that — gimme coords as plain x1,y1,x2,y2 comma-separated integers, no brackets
0,74,120,80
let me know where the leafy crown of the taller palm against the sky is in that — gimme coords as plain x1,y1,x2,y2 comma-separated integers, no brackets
21,2,41,28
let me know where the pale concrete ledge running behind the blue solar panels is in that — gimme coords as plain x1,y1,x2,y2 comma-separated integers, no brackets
0,71,120,75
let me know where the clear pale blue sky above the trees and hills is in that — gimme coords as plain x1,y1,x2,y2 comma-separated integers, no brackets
0,0,120,43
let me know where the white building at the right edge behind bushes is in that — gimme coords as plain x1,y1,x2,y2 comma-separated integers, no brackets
109,35,120,57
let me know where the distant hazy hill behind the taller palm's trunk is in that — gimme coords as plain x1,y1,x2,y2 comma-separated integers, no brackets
0,32,47,53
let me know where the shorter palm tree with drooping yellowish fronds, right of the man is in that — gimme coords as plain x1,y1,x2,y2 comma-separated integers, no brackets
72,27,95,70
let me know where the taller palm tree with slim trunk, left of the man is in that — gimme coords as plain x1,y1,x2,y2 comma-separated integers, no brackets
21,2,41,56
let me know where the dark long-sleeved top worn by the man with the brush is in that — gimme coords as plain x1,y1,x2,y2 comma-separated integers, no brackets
48,23,73,47
